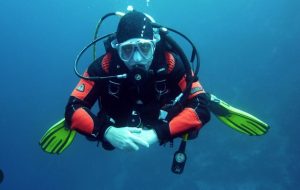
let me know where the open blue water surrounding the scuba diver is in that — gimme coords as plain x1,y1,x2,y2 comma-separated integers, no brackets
0,0,300,190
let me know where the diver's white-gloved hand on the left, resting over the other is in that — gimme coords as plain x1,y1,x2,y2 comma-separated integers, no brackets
104,126,149,151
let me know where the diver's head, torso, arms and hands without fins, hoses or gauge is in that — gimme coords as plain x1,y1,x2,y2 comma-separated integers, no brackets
65,11,210,150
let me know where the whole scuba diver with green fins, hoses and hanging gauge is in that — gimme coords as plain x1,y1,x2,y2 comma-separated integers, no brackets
40,7,269,174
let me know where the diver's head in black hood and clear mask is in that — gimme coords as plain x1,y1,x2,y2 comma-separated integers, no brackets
112,11,159,71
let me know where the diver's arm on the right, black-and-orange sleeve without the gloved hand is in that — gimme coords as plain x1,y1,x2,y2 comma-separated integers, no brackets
154,52,210,143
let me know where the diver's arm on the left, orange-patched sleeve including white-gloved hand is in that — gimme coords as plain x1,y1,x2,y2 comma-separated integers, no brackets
65,57,149,150
